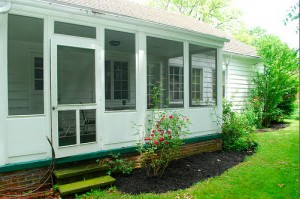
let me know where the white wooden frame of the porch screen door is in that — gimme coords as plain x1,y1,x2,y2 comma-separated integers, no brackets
50,35,101,158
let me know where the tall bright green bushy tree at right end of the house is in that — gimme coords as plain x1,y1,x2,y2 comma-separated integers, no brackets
251,35,299,127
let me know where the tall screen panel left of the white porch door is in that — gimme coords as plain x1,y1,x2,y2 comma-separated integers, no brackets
8,14,44,115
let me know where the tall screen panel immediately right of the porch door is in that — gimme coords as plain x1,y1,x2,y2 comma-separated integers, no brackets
105,30,136,111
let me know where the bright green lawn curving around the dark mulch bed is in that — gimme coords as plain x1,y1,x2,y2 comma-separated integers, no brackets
78,120,299,199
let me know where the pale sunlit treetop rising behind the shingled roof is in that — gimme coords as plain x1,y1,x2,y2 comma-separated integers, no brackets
149,0,242,32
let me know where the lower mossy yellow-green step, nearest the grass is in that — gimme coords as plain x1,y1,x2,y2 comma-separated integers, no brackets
58,175,116,196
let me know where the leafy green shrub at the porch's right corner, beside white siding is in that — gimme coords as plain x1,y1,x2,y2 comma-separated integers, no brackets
222,100,257,151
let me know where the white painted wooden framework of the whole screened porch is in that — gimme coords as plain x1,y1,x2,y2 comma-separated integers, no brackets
0,0,230,165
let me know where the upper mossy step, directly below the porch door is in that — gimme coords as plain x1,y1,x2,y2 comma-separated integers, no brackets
53,164,107,180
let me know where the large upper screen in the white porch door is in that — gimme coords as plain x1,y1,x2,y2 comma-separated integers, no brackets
57,46,95,104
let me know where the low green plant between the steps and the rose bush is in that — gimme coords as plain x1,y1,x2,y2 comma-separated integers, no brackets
97,154,133,175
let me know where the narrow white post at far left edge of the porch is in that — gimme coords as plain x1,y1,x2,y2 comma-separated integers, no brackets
0,13,8,166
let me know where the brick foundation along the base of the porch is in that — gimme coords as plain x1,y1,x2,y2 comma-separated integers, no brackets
0,139,222,193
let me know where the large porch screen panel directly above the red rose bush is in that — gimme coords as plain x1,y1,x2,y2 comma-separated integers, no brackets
147,37,184,109
